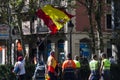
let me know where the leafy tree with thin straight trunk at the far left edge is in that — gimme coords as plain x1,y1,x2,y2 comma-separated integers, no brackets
0,0,11,64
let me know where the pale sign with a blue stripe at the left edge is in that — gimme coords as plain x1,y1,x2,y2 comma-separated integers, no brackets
0,24,9,39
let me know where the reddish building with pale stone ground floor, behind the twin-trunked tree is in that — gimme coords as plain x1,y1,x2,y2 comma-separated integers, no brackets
73,0,112,58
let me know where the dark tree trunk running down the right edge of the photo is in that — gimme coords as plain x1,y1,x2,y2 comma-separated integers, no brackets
112,0,120,63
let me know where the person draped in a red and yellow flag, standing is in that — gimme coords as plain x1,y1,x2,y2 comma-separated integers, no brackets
47,51,57,80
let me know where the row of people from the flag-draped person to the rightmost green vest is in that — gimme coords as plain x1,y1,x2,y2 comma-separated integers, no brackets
46,51,111,80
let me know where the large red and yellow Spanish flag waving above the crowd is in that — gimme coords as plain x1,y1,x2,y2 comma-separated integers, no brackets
37,5,73,34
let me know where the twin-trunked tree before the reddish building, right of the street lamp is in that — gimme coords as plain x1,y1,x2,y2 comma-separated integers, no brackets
76,0,104,54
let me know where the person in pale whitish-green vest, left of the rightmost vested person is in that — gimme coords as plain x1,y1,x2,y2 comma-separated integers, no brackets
88,54,100,80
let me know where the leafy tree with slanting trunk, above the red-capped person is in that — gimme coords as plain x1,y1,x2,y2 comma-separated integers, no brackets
9,0,26,57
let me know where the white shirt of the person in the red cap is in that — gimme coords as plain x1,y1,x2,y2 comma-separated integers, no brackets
14,59,25,75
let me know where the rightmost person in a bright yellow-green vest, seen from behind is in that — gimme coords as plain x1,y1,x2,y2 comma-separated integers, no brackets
100,53,111,80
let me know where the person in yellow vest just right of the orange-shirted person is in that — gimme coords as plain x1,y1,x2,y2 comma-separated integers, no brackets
74,55,81,80
